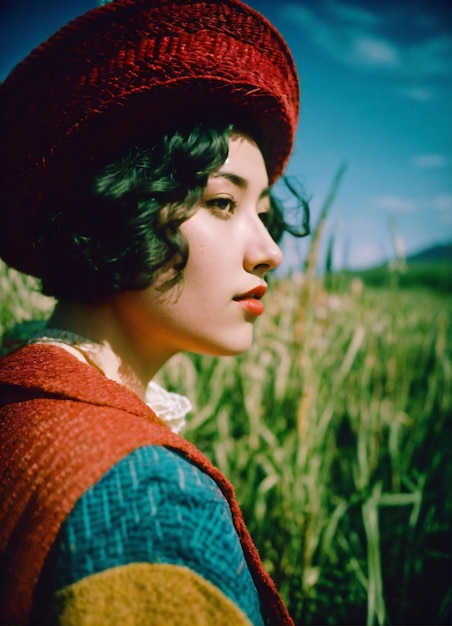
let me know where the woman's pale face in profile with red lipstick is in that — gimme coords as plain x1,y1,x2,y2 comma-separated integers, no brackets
112,134,282,366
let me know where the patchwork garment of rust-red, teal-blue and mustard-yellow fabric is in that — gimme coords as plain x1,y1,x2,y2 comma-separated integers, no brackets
0,344,293,626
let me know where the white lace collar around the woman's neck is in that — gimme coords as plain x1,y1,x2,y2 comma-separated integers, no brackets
28,328,192,433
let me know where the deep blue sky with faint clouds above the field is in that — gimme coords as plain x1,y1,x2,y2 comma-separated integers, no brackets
0,0,452,268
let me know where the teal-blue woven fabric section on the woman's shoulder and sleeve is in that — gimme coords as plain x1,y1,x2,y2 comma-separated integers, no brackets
35,446,263,625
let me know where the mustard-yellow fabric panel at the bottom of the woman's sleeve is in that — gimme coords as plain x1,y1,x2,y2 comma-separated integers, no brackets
49,563,251,626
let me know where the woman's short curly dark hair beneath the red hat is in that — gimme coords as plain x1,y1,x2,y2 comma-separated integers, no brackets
36,123,309,303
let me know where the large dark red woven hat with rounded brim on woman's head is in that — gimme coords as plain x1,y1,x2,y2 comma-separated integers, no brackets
0,0,299,275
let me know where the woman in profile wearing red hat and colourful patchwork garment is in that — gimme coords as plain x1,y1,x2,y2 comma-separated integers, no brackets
0,0,308,625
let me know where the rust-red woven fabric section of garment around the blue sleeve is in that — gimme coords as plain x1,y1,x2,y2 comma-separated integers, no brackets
0,344,293,625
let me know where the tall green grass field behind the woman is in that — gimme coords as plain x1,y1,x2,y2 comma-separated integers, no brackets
0,258,452,625
